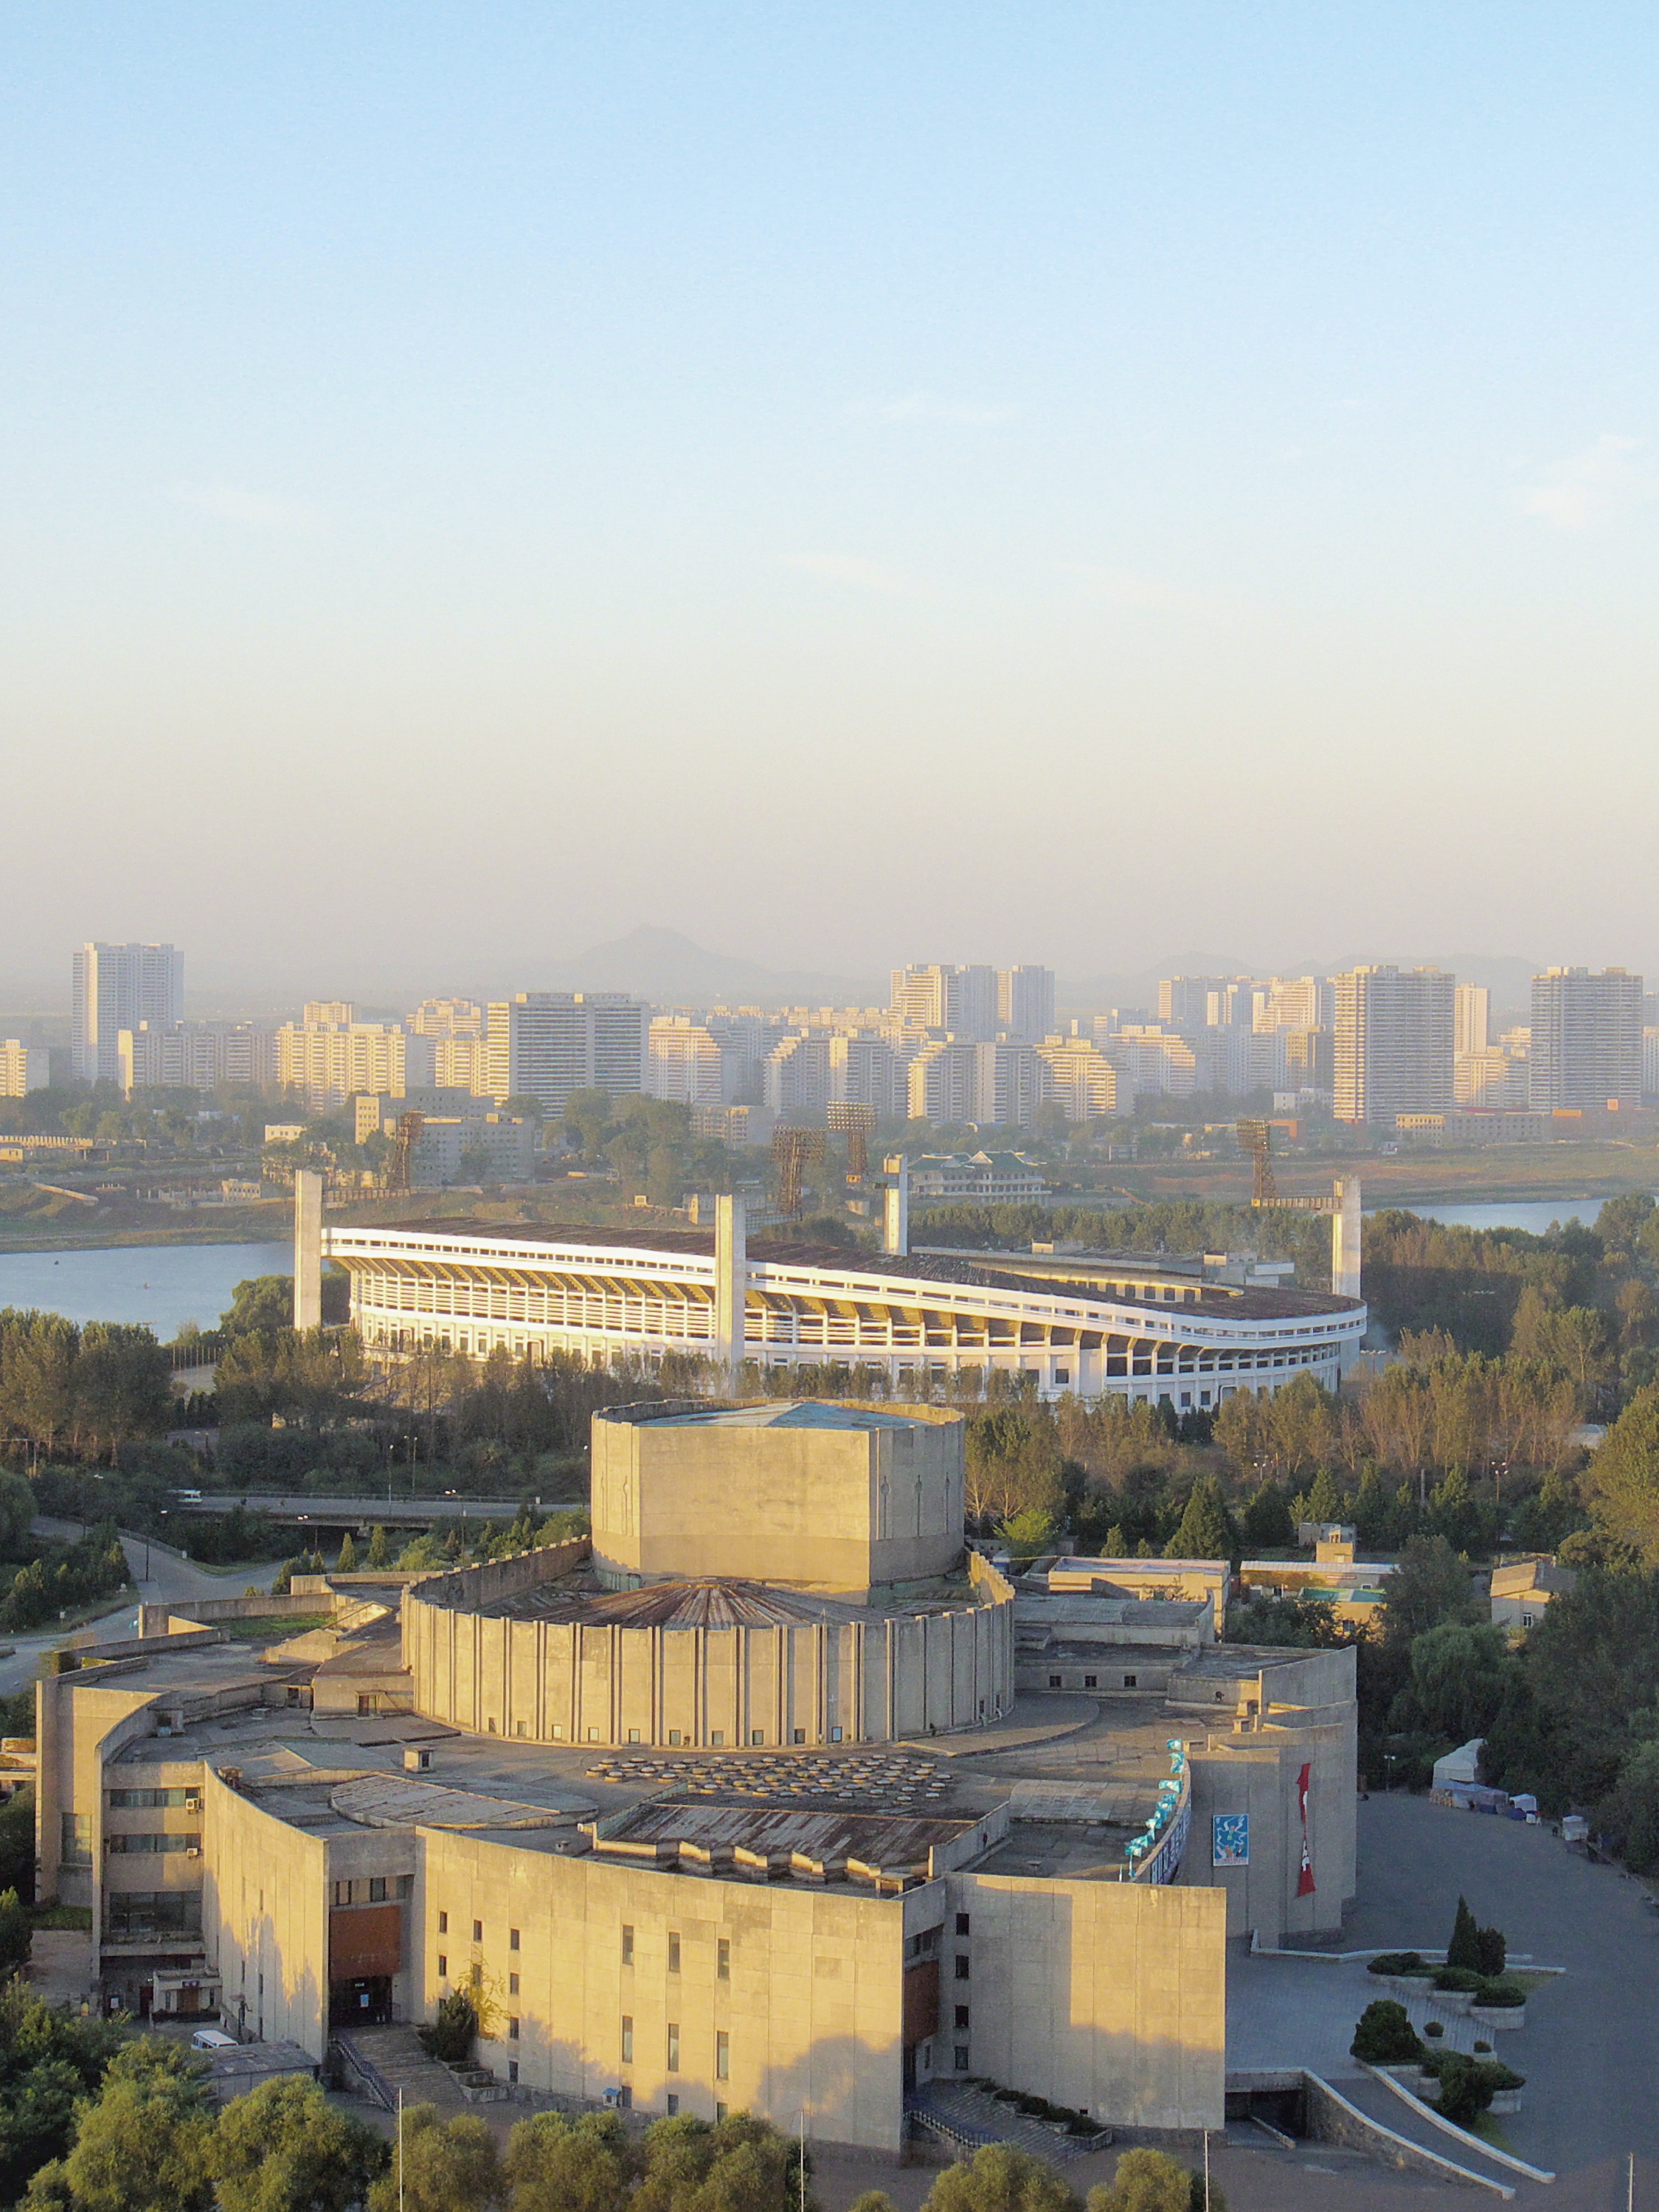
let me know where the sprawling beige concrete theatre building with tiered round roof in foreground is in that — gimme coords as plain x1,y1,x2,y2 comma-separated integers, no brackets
38,1402,1354,2154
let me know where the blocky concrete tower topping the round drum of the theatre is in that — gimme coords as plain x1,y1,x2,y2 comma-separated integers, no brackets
591,1400,964,1595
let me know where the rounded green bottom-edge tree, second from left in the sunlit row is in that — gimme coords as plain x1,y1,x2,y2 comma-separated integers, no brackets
208,2075,387,2212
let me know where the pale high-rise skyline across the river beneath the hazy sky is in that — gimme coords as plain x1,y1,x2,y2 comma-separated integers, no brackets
0,945,1659,1141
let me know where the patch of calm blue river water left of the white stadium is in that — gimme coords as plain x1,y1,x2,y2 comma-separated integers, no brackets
0,1243,294,1342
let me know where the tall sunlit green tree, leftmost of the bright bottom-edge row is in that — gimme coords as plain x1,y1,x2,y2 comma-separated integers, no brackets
64,2037,212,2212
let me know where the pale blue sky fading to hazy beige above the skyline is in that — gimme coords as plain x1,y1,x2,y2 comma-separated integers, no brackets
0,0,1659,1005
